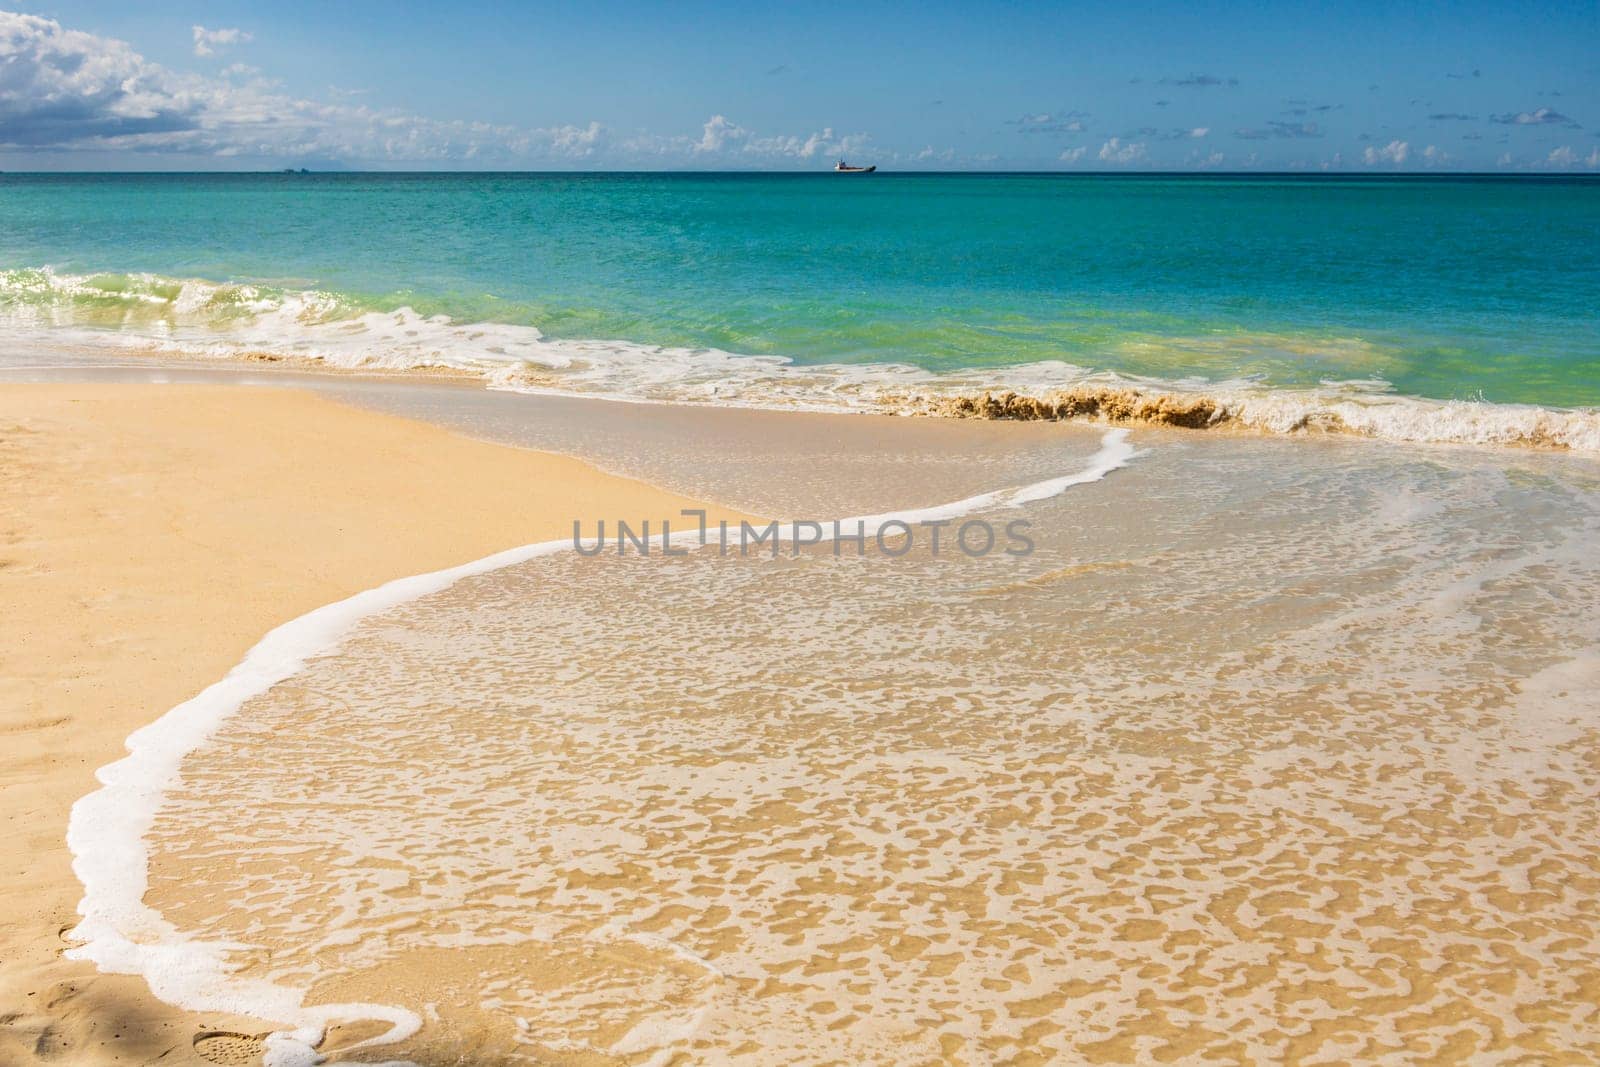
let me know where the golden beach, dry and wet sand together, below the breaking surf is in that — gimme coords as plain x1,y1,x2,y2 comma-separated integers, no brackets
0,365,1600,1065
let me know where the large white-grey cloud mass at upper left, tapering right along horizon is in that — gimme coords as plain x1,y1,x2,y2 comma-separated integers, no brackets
0,11,866,166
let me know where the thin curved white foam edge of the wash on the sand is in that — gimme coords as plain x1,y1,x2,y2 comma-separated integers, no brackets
67,429,1141,1067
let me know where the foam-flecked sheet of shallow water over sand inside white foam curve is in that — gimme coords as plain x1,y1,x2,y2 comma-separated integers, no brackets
140,450,1600,1064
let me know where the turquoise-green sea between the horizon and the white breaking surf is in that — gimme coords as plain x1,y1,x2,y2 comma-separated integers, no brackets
0,174,1600,406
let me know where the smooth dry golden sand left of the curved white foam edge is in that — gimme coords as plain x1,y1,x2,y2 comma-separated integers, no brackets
0,384,752,1064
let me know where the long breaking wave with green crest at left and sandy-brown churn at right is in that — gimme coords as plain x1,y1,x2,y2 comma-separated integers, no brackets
0,267,1600,454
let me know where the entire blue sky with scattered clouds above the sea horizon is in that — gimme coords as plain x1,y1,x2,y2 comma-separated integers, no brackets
0,0,1600,173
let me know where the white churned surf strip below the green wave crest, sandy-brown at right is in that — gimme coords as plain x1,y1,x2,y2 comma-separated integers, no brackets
3,303,1600,456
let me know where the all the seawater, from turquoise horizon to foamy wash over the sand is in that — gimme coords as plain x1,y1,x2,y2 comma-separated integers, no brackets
12,174,1600,1067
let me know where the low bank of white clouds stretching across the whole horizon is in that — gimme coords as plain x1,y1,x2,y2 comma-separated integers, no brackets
0,11,1600,171
